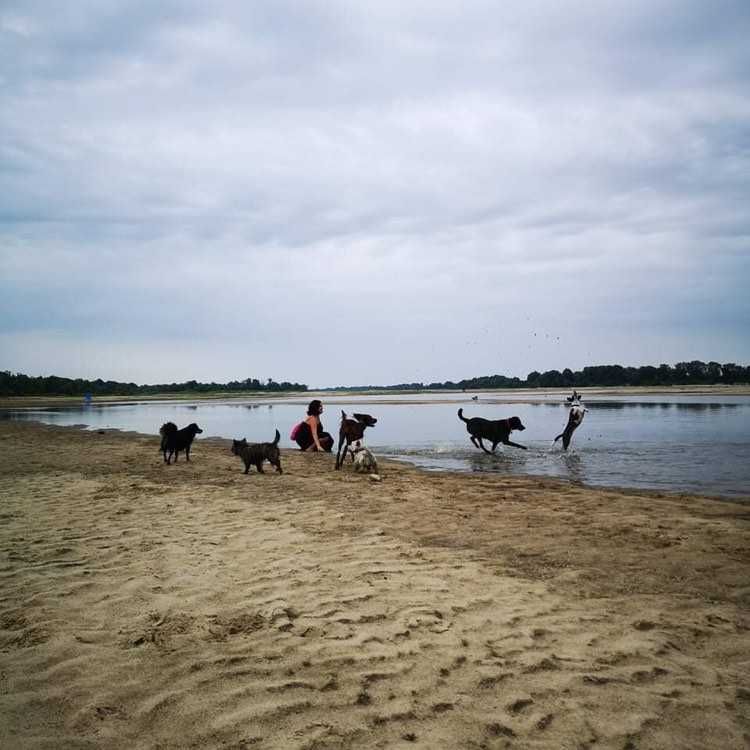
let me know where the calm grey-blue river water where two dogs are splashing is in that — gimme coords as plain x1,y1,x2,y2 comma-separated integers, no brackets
0,393,750,506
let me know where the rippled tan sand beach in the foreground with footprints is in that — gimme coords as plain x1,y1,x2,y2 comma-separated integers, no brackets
0,421,750,750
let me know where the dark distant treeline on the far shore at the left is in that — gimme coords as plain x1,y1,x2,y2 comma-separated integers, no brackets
0,371,307,396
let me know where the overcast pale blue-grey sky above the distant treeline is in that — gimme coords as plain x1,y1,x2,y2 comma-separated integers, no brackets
0,0,750,387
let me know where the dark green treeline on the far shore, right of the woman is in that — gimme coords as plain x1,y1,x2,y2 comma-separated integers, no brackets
331,360,750,391
